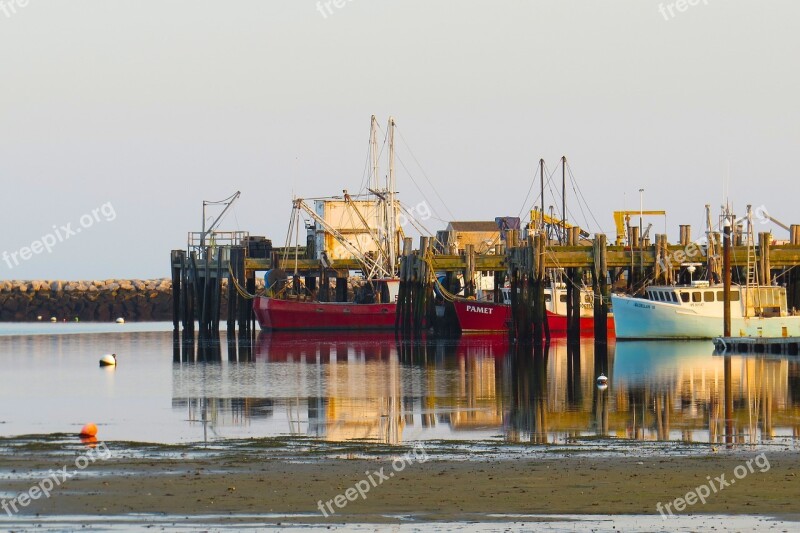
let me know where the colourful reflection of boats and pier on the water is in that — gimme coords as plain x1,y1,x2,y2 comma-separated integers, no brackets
173,332,800,444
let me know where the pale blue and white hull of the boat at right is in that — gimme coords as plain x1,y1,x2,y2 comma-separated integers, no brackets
611,295,800,339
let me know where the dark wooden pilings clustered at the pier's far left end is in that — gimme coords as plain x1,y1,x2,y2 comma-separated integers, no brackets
170,246,256,362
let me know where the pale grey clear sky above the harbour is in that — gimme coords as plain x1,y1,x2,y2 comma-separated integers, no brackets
0,0,800,280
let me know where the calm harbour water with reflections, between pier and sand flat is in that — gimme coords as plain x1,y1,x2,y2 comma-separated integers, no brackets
0,323,800,446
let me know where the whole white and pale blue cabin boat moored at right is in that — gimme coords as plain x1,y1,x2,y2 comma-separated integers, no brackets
611,281,800,339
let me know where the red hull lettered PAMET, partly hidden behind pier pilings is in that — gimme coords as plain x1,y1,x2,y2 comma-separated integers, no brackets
453,299,614,335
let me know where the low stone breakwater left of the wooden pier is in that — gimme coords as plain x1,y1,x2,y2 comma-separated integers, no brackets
0,279,172,322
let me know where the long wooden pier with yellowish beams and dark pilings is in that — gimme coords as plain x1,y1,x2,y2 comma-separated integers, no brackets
171,225,800,344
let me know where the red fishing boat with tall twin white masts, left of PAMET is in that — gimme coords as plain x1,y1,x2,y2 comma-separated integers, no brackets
253,116,403,331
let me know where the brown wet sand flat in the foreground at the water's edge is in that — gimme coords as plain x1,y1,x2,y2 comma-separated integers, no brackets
0,440,800,524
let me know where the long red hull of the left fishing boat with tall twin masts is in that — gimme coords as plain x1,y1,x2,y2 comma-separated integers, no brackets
253,296,397,330
